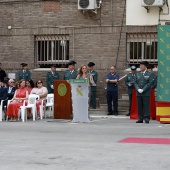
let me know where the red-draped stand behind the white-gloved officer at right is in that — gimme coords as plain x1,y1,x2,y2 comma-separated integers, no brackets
130,89,156,120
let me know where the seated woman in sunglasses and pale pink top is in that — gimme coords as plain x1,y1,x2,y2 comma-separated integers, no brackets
30,80,48,118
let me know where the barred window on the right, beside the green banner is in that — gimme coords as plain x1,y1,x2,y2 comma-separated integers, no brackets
127,33,158,64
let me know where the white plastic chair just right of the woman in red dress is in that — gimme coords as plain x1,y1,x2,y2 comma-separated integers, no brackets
21,94,40,122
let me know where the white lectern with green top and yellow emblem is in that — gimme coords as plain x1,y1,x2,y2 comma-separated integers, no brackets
70,79,89,122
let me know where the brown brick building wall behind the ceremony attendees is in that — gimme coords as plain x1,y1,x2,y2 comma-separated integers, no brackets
0,0,156,103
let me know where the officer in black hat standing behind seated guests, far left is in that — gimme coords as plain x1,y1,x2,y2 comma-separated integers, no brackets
18,63,31,80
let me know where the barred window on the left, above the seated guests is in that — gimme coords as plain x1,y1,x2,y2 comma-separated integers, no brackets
35,35,69,67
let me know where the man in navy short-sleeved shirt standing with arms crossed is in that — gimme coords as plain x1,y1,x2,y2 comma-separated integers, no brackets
106,66,119,116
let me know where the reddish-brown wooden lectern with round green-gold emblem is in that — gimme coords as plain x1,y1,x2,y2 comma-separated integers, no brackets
54,80,72,119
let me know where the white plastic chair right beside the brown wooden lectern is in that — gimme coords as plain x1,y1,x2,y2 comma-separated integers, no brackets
44,94,54,118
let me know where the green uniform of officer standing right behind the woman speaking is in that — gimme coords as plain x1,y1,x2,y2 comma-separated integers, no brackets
89,70,98,109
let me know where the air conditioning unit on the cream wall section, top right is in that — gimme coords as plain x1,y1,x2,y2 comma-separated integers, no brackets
141,0,165,7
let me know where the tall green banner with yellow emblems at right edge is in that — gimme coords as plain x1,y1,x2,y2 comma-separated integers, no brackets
156,25,170,102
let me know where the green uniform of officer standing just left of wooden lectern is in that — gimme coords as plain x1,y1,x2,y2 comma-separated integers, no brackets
46,71,60,93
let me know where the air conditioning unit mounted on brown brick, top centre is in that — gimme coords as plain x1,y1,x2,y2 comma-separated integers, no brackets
78,0,97,10
